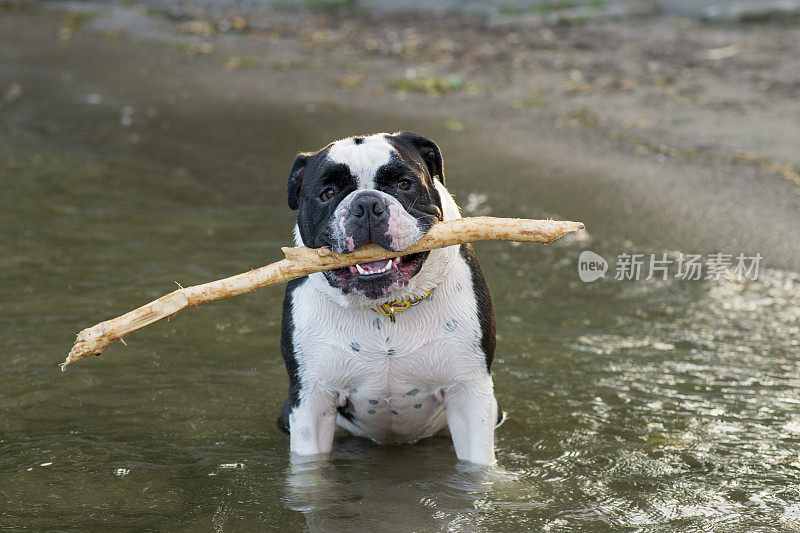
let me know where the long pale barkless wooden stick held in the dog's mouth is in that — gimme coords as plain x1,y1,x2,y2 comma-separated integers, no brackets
61,217,583,370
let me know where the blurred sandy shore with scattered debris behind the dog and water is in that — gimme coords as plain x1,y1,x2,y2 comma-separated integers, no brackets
0,3,800,269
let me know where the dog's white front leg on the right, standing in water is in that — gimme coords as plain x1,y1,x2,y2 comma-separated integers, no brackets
444,376,497,465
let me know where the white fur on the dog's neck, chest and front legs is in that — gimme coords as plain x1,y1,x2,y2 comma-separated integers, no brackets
289,177,497,464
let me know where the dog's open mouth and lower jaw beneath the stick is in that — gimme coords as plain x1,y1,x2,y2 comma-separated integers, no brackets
325,252,429,299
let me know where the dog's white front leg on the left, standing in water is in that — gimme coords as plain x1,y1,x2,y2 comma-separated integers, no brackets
289,388,338,456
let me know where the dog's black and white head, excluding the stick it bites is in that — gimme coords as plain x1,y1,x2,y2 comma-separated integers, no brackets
287,132,444,300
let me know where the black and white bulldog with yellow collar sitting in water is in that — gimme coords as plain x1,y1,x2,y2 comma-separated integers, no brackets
279,133,502,464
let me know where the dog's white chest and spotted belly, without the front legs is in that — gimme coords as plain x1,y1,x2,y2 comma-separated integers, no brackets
292,261,486,442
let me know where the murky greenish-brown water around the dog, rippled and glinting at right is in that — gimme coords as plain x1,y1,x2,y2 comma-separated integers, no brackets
0,14,800,531
